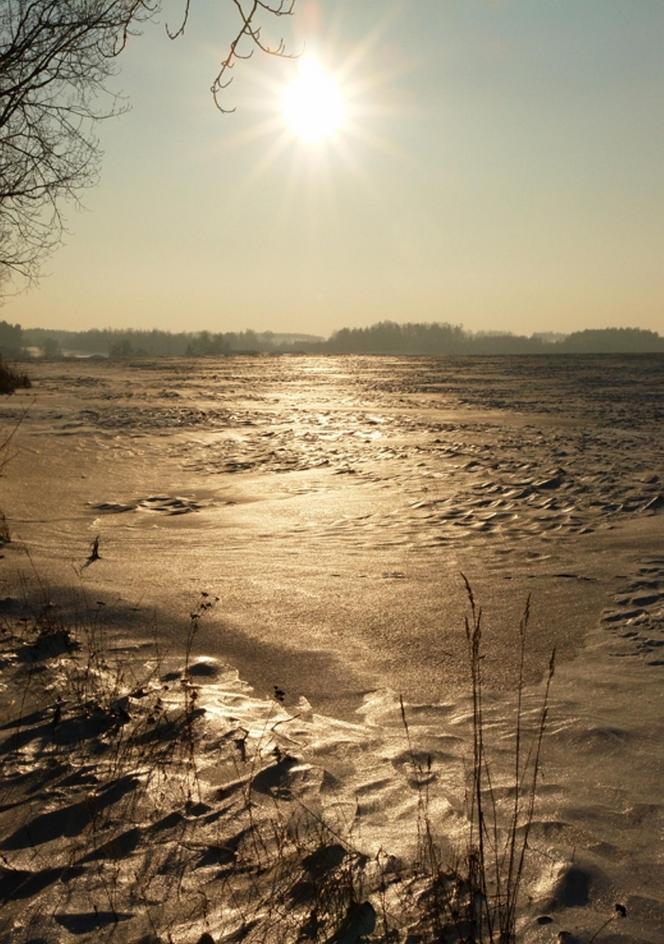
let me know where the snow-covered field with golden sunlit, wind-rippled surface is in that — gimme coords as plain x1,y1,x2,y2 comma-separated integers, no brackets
0,357,664,944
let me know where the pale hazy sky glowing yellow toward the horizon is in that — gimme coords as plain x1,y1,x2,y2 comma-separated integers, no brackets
5,0,664,335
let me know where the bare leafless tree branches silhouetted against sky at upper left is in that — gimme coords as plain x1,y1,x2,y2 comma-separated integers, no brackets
0,0,295,294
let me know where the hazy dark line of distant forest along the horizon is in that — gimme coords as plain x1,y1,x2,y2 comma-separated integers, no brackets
5,321,664,358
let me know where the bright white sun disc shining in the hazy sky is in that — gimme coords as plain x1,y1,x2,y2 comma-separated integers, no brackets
281,58,346,143
